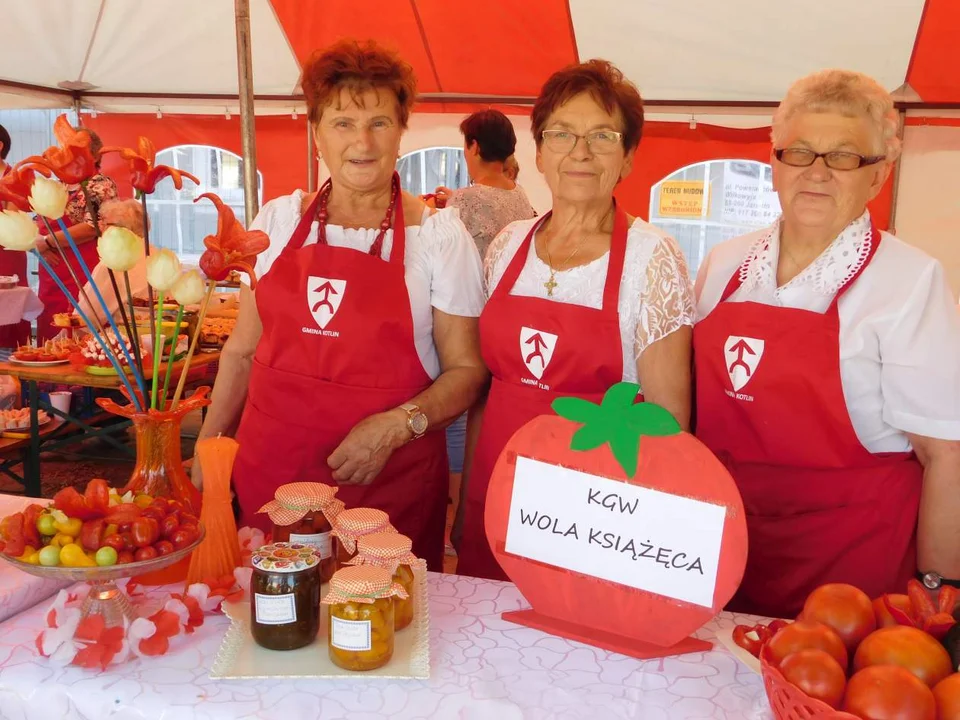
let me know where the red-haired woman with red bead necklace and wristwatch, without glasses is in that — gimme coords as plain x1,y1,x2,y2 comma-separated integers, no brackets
197,42,487,570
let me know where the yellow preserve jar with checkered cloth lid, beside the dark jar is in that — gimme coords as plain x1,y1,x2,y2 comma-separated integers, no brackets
322,565,407,670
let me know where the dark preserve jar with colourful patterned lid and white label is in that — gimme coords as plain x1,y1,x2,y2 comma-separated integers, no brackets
250,542,320,650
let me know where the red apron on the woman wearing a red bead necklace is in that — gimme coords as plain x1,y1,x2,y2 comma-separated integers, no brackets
233,178,449,571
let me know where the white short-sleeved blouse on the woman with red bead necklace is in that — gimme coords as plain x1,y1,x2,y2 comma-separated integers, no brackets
246,190,484,378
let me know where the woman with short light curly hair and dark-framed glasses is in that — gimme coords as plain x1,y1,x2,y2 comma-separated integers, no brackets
694,70,960,617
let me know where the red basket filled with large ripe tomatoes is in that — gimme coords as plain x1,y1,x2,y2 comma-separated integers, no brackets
734,580,960,720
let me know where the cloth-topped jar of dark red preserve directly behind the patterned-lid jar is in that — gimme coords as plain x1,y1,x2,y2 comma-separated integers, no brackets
258,482,343,582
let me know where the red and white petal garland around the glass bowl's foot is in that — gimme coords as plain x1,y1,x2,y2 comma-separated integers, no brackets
36,568,251,670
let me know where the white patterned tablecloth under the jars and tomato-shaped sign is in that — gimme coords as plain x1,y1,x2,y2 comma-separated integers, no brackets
0,574,772,720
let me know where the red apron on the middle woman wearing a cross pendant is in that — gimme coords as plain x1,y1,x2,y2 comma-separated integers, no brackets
457,208,639,580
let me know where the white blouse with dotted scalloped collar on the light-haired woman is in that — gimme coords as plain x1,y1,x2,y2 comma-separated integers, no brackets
696,213,960,453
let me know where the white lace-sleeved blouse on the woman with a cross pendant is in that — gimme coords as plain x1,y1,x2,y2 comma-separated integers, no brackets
484,219,695,382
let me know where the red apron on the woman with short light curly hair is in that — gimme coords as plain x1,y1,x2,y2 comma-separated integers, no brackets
693,228,923,617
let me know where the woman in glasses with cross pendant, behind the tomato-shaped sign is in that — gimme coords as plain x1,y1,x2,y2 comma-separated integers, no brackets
457,60,694,579
